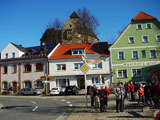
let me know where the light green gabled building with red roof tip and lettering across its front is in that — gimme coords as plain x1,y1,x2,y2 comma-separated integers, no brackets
110,12,160,82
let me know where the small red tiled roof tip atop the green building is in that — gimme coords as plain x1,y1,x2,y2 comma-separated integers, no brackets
132,11,156,20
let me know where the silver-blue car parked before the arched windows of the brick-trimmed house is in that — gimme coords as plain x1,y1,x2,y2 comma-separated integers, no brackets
20,88,42,95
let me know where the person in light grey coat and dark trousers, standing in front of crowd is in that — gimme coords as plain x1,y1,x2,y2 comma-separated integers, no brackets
114,81,125,112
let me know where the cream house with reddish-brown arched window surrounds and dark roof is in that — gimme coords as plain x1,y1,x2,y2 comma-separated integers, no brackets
0,45,56,94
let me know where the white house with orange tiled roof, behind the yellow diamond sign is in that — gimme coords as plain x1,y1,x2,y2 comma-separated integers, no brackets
49,43,111,89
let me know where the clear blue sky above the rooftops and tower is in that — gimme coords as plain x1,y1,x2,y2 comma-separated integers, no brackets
0,0,160,51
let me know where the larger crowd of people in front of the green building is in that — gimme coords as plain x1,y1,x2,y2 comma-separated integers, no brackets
114,81,160,112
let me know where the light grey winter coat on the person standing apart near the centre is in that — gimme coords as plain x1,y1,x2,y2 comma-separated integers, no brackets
114,86,125,100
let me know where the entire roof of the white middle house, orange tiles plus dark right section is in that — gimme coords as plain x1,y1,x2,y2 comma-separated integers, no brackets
49,43,109,59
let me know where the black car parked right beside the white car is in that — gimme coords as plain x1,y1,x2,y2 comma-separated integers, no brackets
65,86,78,95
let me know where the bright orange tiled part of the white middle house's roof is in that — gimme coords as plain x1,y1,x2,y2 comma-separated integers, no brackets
49,43,109,59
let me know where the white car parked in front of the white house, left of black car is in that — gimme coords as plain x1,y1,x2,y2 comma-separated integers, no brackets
50,87,65,95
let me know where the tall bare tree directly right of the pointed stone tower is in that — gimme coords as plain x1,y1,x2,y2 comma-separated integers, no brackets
77,8,99,35
